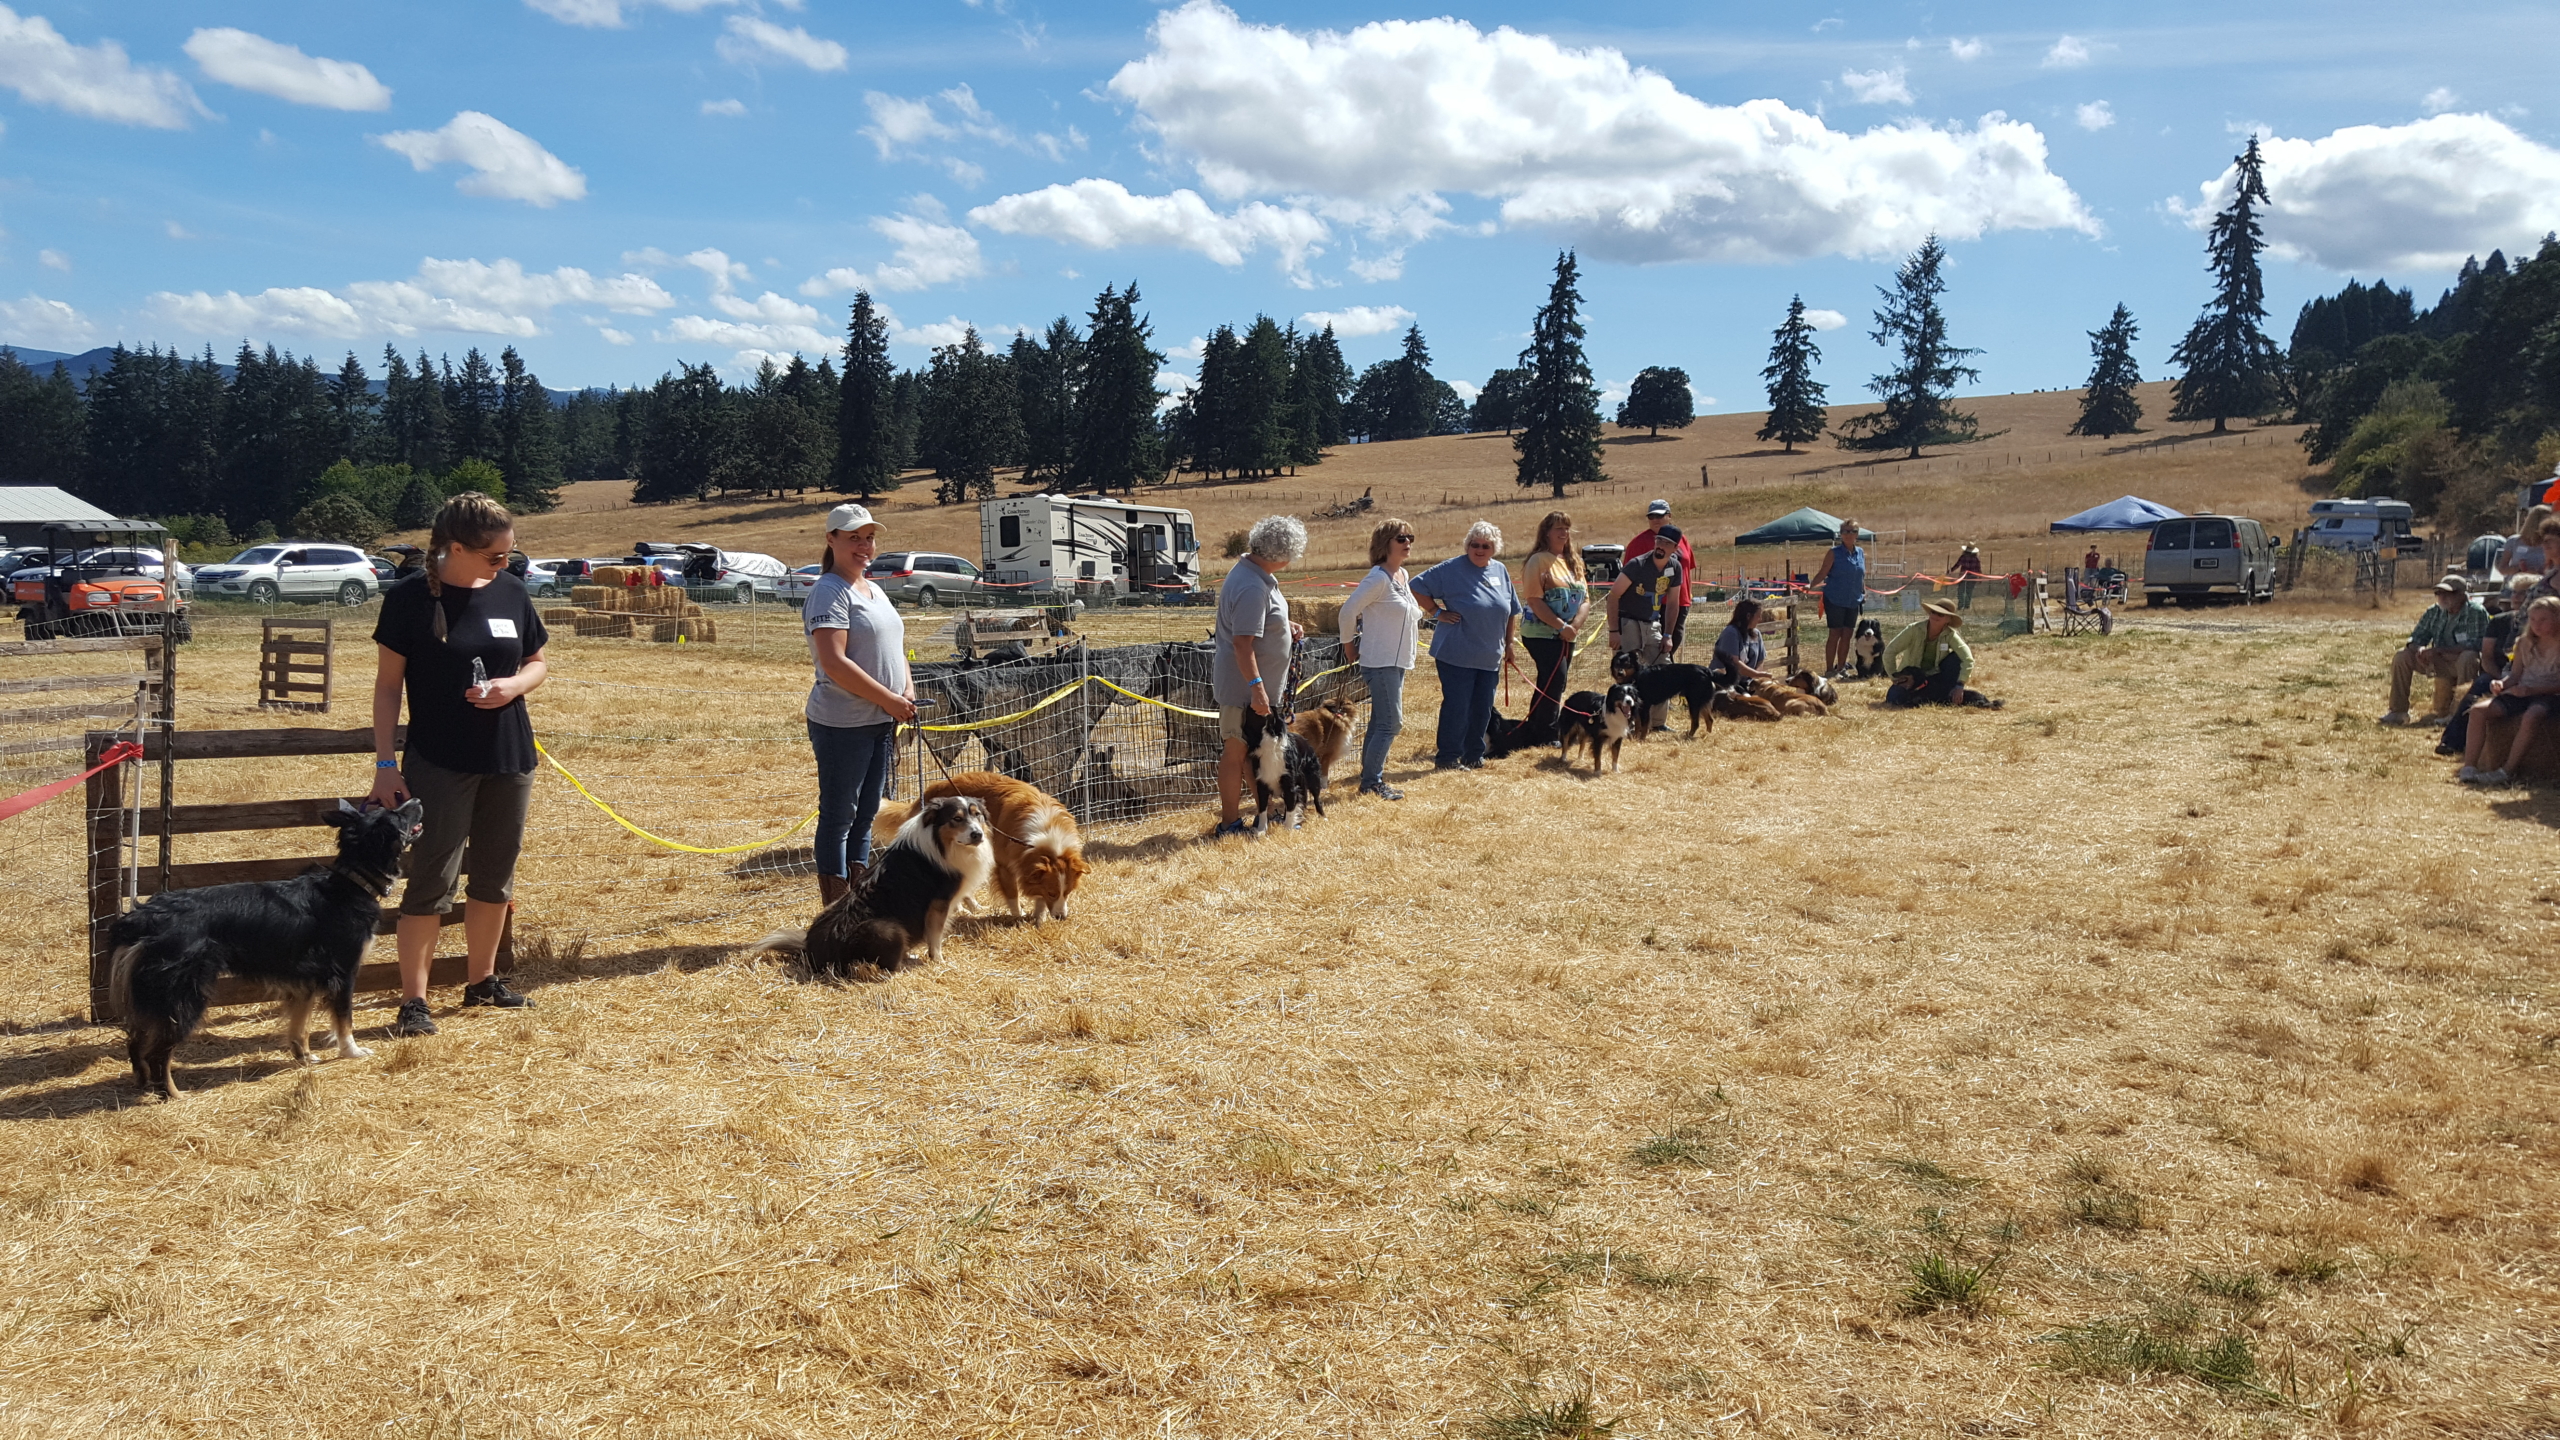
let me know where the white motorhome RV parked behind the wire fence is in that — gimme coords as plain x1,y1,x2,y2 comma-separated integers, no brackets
978,495,1201,594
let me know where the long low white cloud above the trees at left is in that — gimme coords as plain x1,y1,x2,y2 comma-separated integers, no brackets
148,259,676,341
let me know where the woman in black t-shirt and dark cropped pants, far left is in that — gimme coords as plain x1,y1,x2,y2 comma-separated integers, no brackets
374,492,550,1035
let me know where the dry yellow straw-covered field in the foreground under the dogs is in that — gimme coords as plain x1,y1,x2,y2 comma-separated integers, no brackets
0,591,2560,1437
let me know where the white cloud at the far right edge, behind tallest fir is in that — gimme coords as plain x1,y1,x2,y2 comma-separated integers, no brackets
2171,115,2560,272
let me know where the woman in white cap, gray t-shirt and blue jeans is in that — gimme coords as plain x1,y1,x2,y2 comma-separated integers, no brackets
801,505,916,904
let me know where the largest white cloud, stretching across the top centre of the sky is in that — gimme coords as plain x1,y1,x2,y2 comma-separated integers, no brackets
1095,0,2097,261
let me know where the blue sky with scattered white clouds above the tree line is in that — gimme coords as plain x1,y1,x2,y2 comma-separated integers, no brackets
0,0,2560,410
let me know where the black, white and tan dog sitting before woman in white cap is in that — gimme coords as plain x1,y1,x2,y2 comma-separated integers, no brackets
755,794,996,976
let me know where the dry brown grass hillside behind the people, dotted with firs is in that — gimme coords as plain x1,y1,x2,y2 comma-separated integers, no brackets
430,384,2309,591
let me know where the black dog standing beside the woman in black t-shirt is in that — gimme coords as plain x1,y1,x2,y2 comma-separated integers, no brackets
108,799,425,1099
